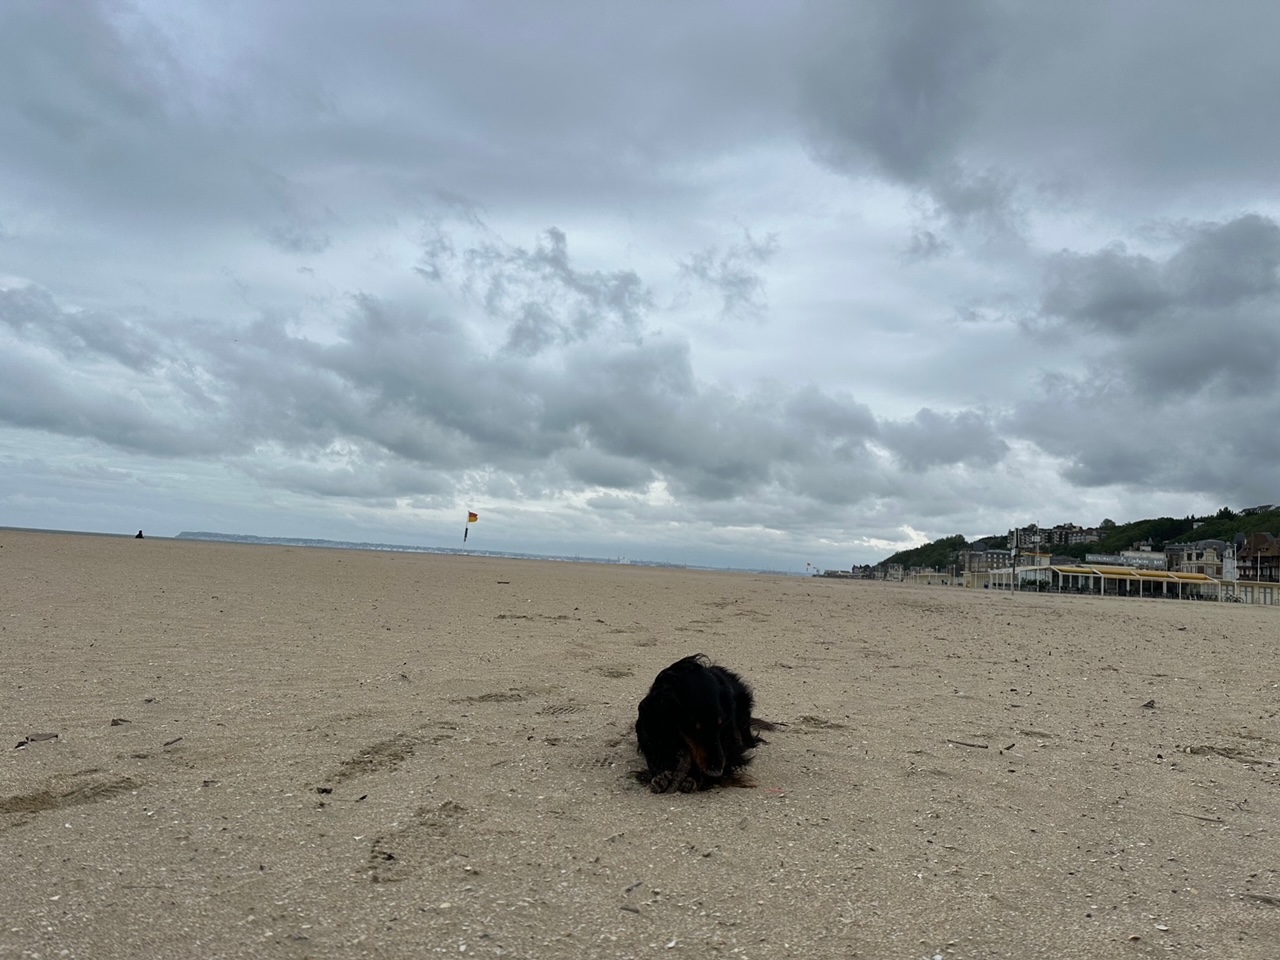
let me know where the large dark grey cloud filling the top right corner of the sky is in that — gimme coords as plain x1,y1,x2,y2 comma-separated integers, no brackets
801,1,1280,244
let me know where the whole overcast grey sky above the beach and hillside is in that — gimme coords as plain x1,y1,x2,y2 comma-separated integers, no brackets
0,0,1280,570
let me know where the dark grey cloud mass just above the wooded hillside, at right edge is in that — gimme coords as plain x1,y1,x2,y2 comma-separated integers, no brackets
1014,215,1280,504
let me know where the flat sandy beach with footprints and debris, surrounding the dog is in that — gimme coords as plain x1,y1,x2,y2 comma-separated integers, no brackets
0,531,1280,960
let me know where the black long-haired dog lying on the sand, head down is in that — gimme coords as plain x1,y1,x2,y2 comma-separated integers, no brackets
636,654,773,794
